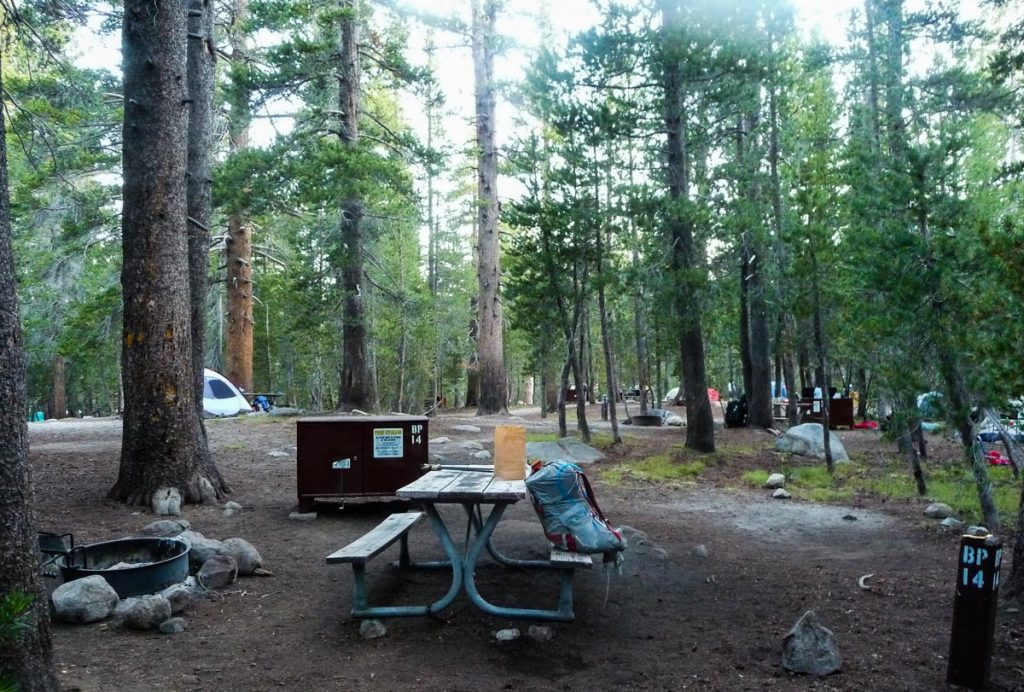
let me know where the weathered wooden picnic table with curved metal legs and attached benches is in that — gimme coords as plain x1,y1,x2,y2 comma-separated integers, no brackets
327,467,592,622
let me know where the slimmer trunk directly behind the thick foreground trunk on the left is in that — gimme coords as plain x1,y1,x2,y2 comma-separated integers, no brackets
185,0,216,467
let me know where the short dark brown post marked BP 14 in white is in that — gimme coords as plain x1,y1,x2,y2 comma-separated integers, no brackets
946,535,1002,690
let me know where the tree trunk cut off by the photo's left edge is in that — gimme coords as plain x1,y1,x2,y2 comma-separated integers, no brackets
0,49,60,692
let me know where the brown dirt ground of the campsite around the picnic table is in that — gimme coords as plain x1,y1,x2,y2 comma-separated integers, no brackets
24,409,1024,691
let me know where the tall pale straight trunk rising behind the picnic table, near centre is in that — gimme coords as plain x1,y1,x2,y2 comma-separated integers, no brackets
470,0,503,416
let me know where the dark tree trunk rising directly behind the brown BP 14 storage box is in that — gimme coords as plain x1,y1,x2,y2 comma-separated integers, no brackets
338,0,380,410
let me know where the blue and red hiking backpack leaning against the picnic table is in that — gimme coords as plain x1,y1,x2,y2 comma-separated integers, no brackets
526,460,626,562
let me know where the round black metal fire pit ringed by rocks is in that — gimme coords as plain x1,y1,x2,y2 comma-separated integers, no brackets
57,538,191,598
